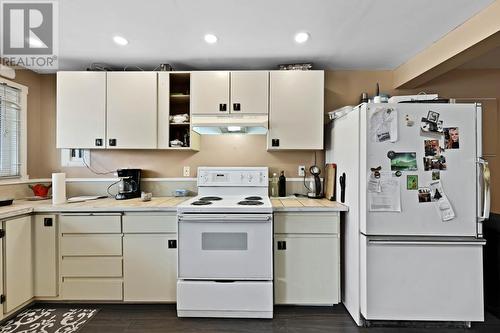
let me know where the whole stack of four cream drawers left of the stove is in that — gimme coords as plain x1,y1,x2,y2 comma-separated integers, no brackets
59,214,123,301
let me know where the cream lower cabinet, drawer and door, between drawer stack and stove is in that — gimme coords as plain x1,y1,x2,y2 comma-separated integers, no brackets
123,213,177,302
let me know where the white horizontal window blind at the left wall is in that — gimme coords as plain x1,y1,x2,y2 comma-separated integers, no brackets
0,83,21,178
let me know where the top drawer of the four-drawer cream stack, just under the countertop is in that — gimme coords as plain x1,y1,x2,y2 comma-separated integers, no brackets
59,215,122,234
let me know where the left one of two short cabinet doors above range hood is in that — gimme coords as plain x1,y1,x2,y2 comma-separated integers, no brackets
191,71,229,115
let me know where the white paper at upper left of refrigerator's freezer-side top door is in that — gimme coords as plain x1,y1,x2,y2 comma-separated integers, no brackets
369,107,398,142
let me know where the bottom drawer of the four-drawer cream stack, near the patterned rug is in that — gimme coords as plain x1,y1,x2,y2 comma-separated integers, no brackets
61,278,123,301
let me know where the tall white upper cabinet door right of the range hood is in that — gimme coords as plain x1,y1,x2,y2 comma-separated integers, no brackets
267,71,324,150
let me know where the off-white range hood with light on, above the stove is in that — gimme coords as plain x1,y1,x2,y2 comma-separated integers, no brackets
191,114,268,134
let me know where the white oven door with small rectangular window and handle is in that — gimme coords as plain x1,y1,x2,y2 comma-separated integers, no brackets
177,214,273,280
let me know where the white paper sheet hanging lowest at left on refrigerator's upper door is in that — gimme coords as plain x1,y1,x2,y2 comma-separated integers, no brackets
367,172,401,212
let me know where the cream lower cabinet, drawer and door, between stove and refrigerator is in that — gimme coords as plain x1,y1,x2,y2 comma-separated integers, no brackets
274,212,340,305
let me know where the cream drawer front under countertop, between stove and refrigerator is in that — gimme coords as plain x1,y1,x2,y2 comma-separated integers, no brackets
274,212,340,234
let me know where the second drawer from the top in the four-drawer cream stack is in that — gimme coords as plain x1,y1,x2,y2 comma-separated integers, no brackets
61,235,122,256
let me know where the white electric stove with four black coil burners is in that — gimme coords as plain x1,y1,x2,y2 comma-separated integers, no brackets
177,167,273,318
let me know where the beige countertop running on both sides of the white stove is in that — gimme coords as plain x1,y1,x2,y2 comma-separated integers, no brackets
0,197,348,219
